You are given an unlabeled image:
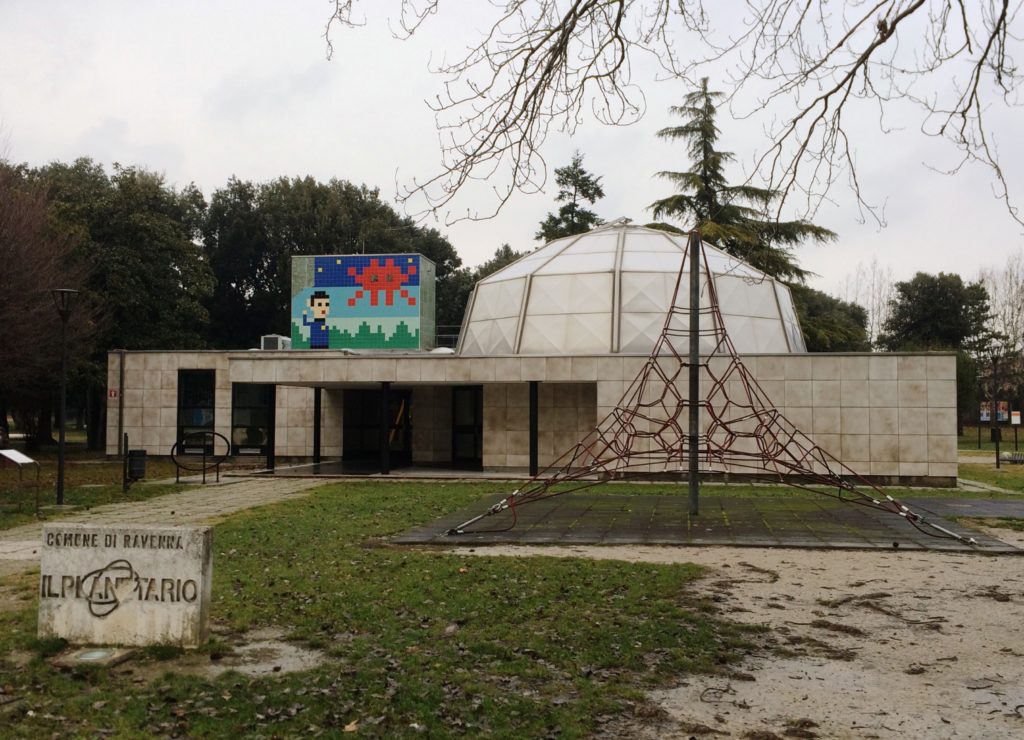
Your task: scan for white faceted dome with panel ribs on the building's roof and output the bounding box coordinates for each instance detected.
[459,221,807,356]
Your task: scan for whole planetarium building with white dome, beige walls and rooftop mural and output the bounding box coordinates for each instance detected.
[108,222,956,484]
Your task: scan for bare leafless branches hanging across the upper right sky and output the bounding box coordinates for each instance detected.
[325,0,1024,226]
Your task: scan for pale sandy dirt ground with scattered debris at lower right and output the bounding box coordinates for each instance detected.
[468,529,1024,740]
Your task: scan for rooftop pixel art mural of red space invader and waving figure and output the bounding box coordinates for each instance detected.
[292,254,434,349]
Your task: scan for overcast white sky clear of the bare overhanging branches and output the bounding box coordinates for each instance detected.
[0,0,1024,293]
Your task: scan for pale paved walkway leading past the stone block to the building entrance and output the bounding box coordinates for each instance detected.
[0,478,325,575]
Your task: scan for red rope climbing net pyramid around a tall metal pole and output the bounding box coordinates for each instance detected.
[449,238,975,545]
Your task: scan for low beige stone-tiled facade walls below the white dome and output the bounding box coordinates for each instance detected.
[106,351,957,485]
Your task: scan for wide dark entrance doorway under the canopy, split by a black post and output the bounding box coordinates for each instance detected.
[341,388,413,470]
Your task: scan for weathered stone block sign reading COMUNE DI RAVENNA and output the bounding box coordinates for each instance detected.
[39,524,213,647]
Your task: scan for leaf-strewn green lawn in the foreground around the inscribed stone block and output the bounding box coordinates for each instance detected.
[0,482,754,737]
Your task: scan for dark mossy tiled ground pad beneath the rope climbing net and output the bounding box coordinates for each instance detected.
[393,492,1024,554]
